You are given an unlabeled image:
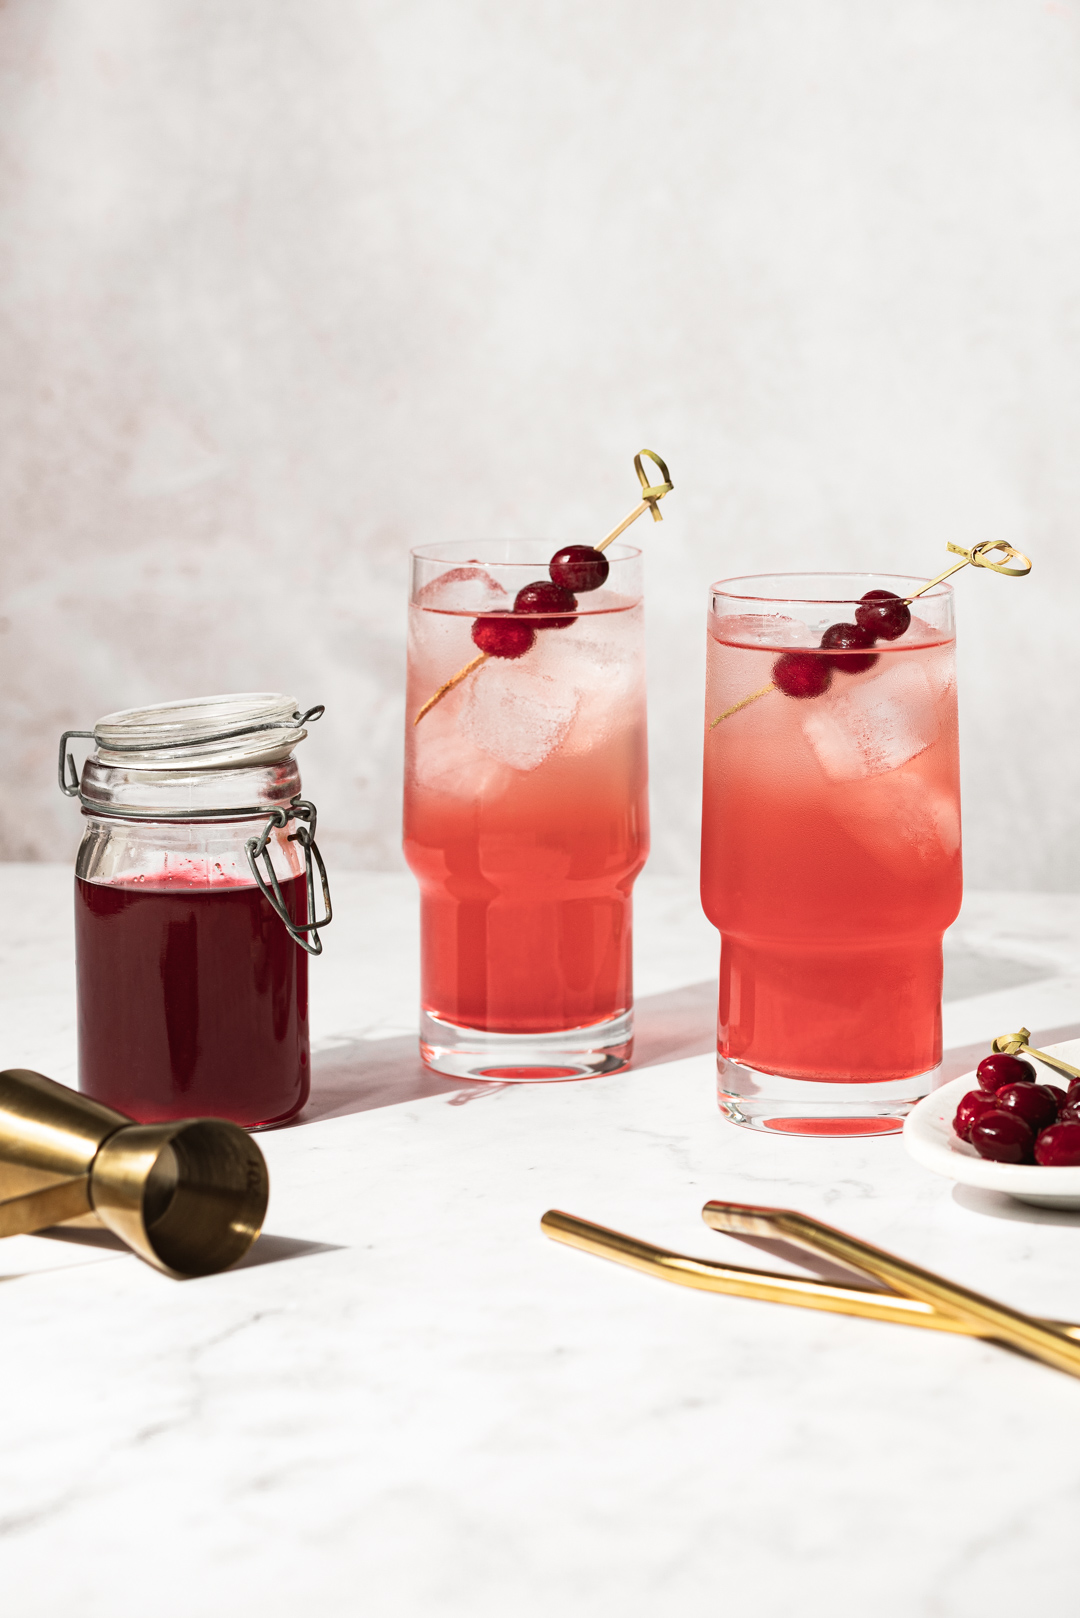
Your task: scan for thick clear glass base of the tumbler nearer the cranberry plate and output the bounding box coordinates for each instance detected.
[716,1055,941,1134]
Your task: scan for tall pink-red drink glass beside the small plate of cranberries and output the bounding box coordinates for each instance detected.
[701,573,960,1134]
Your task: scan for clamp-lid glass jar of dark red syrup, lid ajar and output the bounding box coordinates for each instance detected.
[58,691,332,1129]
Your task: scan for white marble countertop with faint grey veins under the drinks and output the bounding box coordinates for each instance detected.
[0,866,1080,1618]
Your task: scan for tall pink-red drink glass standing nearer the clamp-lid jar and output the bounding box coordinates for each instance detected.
[405,540,649,1082]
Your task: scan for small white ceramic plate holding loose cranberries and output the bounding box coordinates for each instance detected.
[904,1039,1080,1209]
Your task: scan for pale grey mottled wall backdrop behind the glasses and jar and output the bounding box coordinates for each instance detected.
[0,0,1080,888]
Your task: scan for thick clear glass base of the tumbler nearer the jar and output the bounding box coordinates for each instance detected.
[419,1011,633,1084]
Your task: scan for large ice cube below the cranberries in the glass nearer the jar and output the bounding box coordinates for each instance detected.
[460,650,578,770]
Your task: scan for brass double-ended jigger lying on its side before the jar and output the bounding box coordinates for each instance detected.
[0,1068,270,1278]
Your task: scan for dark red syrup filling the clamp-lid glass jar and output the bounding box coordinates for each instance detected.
[74,874,311,1128]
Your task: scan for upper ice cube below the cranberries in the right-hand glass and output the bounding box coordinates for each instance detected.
[803,654,941,781]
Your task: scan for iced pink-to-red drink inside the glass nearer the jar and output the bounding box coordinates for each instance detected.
[405,608,649,1035]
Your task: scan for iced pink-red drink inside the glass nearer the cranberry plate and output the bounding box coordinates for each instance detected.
[701,620,962,1080]
